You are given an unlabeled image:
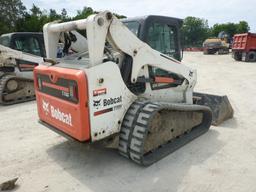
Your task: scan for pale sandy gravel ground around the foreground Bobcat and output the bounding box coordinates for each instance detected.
[0,53,256,192]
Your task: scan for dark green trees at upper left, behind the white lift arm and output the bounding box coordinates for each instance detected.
[0,3,125,35]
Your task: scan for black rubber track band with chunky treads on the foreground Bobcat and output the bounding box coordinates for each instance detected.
[119,101,212,166]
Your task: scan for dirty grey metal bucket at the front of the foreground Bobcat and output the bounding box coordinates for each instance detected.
[193,92,234,126]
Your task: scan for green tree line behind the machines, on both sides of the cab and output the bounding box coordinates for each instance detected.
[0,0,250,47]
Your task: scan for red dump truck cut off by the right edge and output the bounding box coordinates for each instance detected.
[232,33,256,62]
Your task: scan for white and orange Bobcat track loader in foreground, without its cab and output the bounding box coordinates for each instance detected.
[34,11,233,166]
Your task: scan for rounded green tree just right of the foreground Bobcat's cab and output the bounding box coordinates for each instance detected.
[182,16,209,47]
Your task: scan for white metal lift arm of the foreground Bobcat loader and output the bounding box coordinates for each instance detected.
[44,11,196,94]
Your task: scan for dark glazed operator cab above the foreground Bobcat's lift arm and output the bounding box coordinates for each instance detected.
[122,15,183,61]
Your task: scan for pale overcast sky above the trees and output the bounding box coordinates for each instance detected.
[22,0,256,32]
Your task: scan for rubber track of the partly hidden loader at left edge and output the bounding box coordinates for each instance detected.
[0,74,35,105]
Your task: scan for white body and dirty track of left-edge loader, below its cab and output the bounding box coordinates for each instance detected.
[0,45,43,105]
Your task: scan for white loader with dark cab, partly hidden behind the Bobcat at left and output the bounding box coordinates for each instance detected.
[0,31,87,105]
